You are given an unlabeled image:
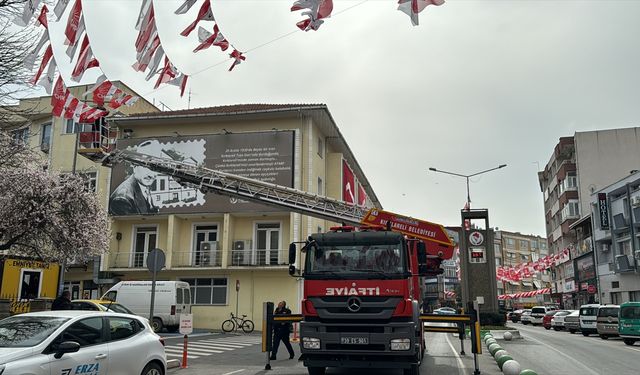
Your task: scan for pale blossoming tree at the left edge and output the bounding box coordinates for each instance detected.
[0,130,109,263]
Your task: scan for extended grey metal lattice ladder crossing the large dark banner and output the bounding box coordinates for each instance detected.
[102,150,367,224]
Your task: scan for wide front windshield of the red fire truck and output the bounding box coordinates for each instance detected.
[305,244,407,279]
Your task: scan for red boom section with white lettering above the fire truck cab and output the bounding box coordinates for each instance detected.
[360,208,453,247]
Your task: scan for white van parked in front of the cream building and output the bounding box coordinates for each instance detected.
[102,281,191,332]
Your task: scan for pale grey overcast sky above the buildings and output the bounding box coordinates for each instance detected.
[42,0,640,236]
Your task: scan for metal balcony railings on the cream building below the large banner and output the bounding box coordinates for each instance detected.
[109,249,288,269]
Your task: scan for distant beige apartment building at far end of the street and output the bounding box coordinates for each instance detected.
[494,230,551,308]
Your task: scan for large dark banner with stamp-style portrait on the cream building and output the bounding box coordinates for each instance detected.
[109,131,294,216]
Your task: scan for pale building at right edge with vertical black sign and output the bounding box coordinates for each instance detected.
[590,173,640,304]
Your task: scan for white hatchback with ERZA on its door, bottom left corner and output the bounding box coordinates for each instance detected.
[0,310,167,375]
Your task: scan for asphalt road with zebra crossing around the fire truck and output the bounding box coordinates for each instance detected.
[165,333,501,375]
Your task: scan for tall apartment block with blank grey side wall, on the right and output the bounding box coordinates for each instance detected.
[538,128,640,301]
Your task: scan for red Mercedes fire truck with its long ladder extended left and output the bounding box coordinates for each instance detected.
[84,132,453,375]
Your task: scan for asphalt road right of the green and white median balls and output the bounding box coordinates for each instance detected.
[498,324,640,375]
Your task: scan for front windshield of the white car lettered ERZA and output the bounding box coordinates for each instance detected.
[0,315,69,348]
